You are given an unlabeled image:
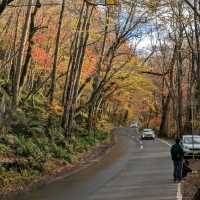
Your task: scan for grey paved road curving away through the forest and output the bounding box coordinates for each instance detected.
[15,128,177,200]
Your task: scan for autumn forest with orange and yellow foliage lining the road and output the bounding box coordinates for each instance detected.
[0,0,200,192]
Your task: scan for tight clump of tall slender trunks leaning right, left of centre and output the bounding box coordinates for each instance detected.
[62,3,94,137]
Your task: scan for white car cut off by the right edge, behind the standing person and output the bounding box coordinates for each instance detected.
[181,135,200,157]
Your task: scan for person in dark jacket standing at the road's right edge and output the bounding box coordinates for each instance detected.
[171,138,184,182]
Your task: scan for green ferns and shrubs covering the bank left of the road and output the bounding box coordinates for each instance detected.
[0,101,111,193]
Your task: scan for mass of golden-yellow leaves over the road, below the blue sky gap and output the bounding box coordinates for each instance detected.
[109,62,158,121]
